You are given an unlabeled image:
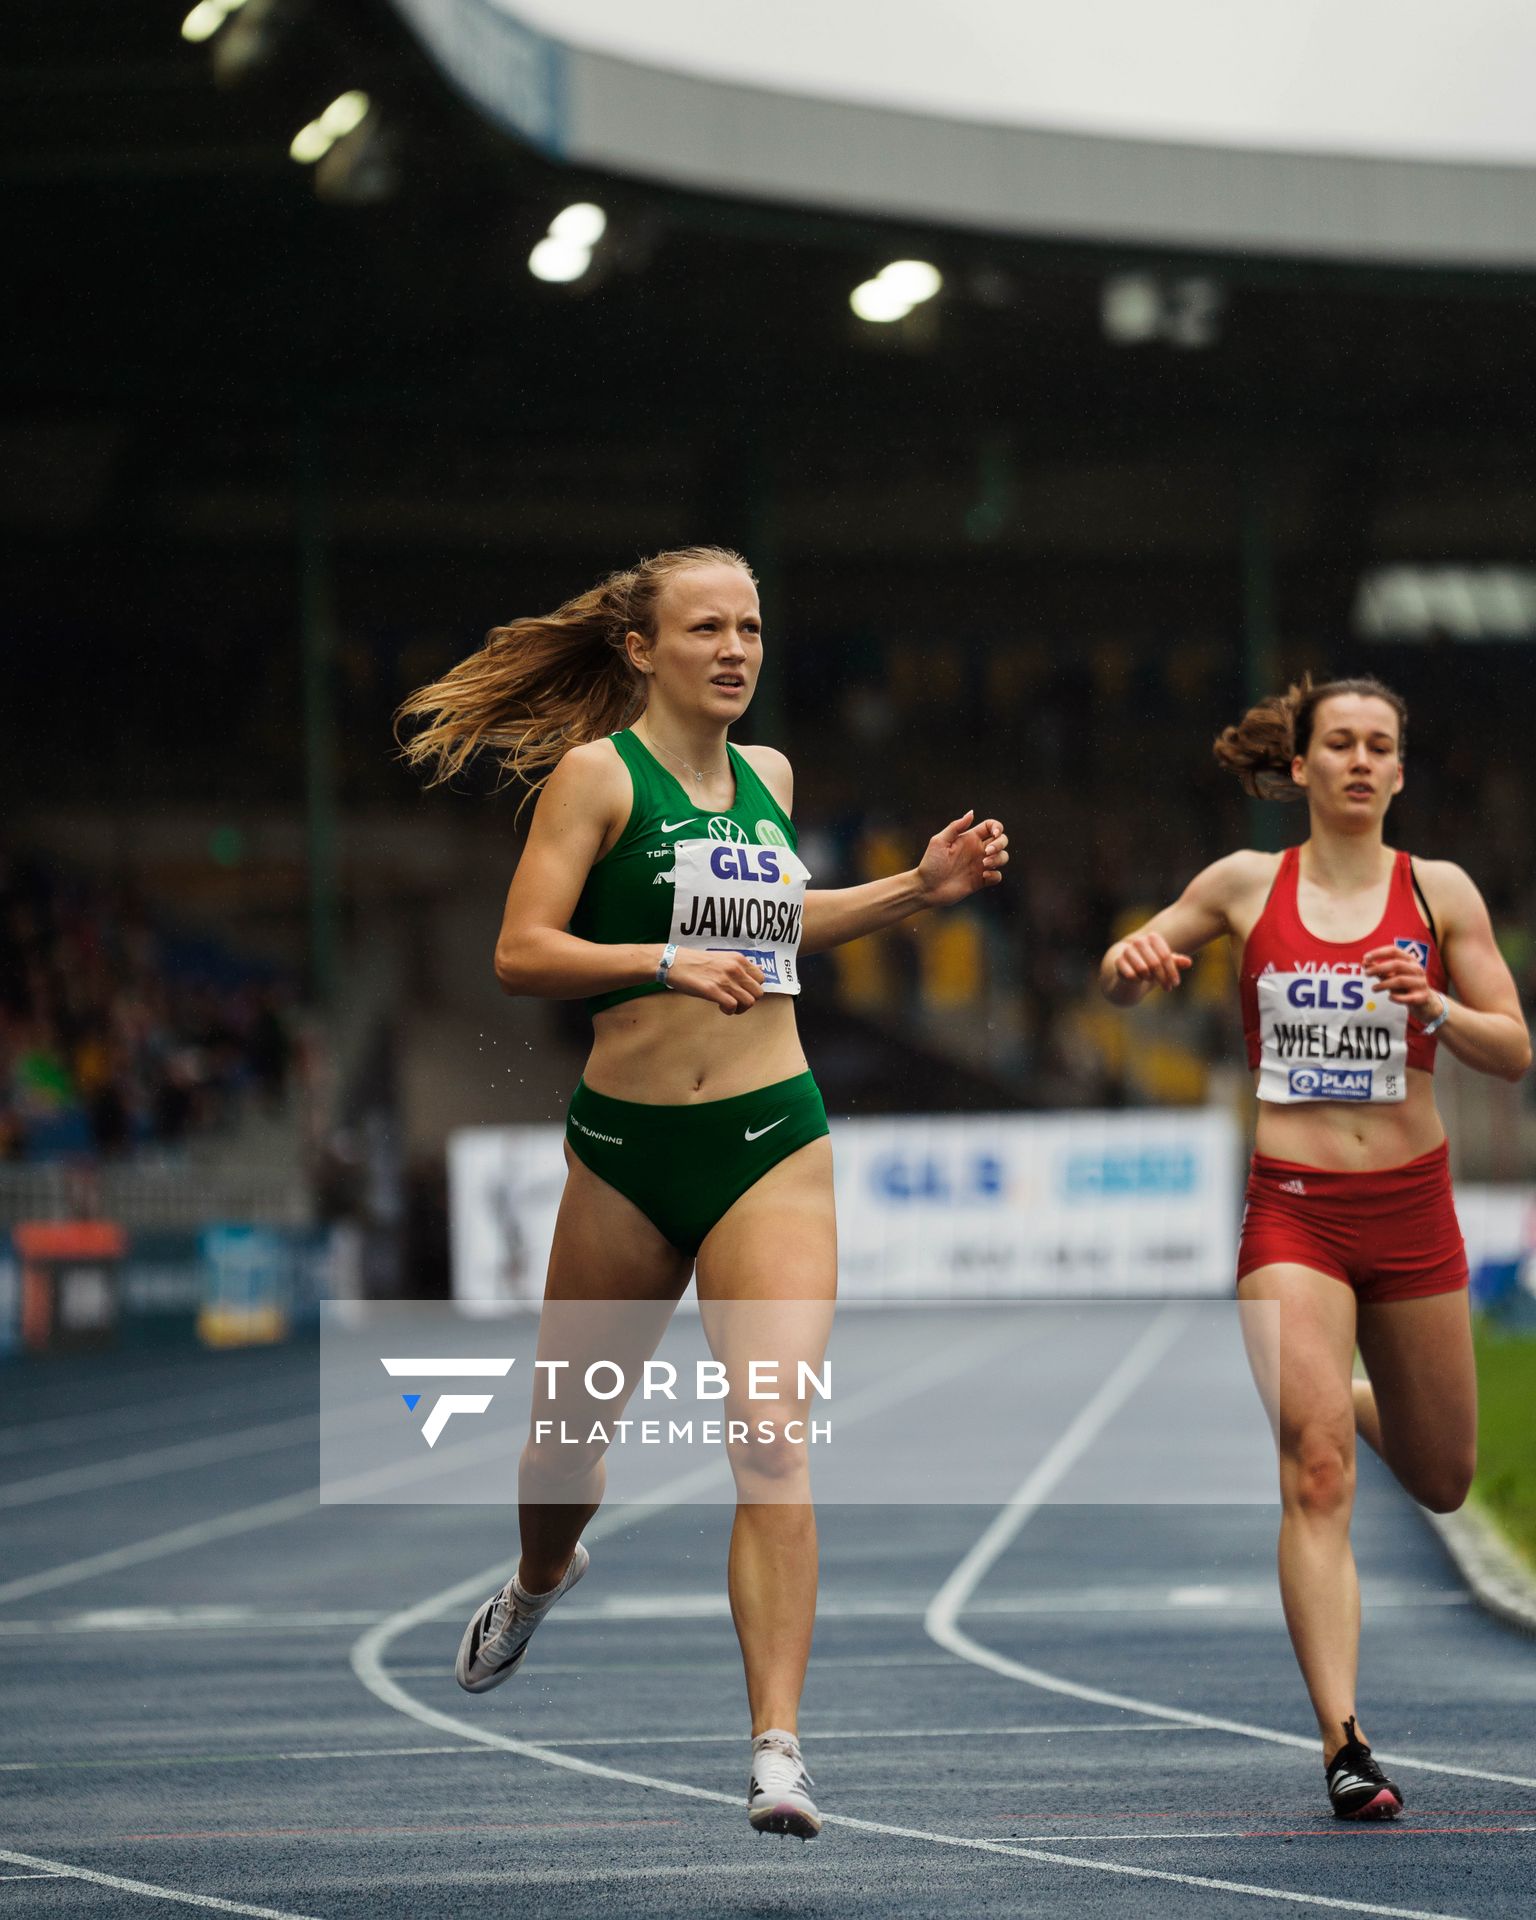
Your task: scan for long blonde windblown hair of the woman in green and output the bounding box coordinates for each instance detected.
[396,547,755,791]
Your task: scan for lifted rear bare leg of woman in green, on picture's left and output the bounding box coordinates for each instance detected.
[516,1148,691,1594]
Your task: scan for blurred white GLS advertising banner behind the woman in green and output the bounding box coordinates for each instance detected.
[449,1110,1240,1300]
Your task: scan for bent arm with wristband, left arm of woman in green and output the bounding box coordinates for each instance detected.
[495,741,762,1014]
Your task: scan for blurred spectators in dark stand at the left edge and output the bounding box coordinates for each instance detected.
[0,849,296,1162]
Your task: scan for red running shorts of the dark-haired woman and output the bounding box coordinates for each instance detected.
[1236,1140,1467,1302]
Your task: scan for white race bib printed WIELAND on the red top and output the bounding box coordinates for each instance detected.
[1256,973,1407,1106]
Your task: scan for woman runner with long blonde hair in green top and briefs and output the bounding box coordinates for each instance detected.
[401,547,1008,1839]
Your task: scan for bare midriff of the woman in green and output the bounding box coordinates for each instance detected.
[584,993,806,1106]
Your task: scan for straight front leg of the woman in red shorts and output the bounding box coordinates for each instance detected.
[1238,1265,1365,1763]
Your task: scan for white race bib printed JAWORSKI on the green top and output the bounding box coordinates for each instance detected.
[668,839,810,993]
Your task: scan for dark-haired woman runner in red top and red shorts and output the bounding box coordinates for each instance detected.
[1100,680,1530,1820]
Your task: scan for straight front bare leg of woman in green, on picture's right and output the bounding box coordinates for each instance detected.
[699,1139,837,1734]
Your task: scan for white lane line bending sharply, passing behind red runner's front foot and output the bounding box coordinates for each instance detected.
[924,1317,1536,1789]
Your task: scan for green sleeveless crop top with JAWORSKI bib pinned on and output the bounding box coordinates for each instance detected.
[570,728,808,1014]
